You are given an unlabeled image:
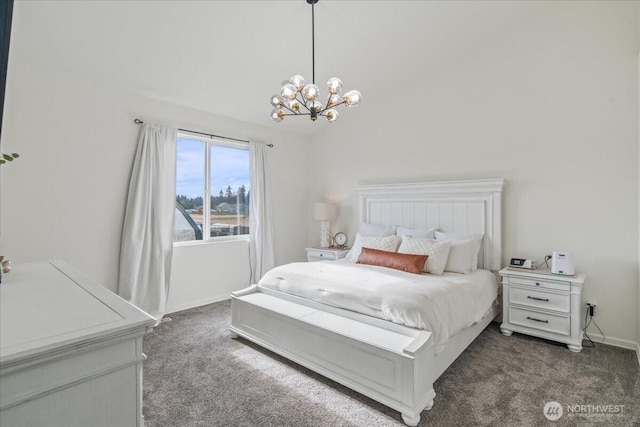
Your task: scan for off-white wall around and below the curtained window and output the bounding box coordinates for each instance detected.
[0,2,308,311]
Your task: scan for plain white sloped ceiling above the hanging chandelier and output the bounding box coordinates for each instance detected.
[14,0,544,135]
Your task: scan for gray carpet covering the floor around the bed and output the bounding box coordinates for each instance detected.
[144,301,640,427]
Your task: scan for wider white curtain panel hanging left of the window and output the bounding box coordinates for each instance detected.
[118,123,177,322]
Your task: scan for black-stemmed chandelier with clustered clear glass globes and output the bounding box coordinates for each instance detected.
[271,0,362,123]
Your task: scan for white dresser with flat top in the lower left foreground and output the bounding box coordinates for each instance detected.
[0,261,155,427]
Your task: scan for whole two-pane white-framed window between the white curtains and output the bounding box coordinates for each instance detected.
[173,134,250,242]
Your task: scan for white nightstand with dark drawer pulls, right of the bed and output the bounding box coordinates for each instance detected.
[499,268,585,352]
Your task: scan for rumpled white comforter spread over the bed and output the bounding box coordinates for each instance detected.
[258,261,499,353]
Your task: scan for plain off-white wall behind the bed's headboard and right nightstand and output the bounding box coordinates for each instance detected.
[308,2,639,348]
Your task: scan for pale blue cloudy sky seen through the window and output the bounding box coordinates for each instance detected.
[176,137,249,197]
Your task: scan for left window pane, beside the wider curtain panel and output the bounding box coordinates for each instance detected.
[173,137,205,242]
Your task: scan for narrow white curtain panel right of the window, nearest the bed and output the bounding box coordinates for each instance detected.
[249,142,275,283]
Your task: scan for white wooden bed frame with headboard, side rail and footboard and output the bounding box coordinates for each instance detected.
[230,179,504,426]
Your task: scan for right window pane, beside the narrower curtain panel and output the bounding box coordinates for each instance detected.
[210,145,250,237]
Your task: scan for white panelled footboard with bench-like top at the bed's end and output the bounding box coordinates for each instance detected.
[230,285,435,425]
